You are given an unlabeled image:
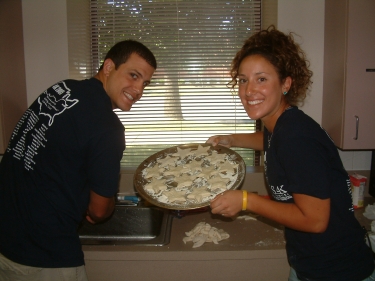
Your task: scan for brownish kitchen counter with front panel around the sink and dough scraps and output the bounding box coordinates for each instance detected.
[83,198,374,281]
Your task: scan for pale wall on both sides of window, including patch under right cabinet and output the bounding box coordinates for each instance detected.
[22,0,371,170]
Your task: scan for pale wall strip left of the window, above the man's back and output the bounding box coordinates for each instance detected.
[22,0,69,105]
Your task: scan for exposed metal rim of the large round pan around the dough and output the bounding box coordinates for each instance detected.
[133,143,246,210]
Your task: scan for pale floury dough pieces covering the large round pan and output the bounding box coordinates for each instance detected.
[142,145,238,206]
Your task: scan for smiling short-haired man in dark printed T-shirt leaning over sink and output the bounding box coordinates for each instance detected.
[0,40,157,280]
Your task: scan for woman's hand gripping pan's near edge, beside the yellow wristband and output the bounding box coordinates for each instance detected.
[210,190,243,217]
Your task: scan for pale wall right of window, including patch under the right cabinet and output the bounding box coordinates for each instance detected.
[277,0,372,170]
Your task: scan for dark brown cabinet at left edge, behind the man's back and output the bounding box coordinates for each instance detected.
[0,0,27,154]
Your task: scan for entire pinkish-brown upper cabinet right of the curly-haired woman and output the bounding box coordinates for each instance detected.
[322,0,375,150]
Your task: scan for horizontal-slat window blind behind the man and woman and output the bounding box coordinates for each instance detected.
[84,0,261,167]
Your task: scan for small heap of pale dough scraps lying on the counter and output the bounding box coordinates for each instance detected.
[182,222,229,248]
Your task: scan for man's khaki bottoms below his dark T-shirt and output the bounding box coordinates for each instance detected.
[0,253,87,281]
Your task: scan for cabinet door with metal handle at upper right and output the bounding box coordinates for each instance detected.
[342,0,375,149]
